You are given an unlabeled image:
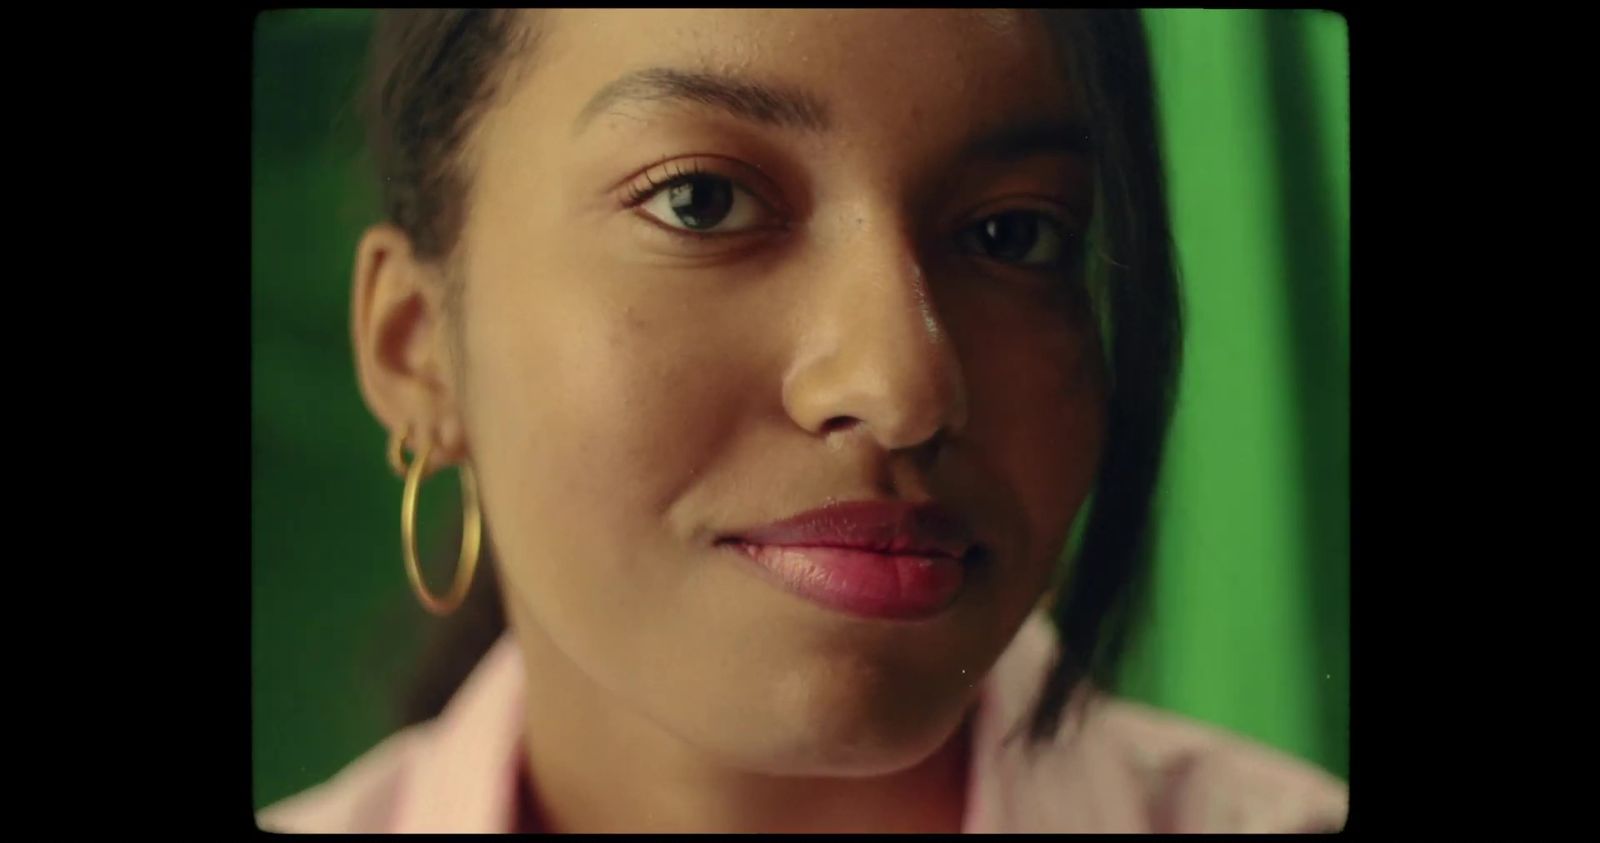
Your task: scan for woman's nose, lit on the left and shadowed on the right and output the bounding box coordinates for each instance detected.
[784,219,966,451]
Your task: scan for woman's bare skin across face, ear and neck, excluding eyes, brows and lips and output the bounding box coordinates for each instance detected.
[354,10,1104,832]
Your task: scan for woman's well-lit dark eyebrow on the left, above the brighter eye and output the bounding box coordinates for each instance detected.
[573,67,829,134]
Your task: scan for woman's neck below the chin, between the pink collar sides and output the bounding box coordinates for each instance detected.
[514,614,971,833]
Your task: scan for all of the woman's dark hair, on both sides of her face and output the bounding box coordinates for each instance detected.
[368,10,1182,742]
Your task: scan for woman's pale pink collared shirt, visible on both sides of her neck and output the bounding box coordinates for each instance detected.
[258,614,1349,833]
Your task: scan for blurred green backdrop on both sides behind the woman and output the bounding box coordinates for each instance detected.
[251,10,1349,808]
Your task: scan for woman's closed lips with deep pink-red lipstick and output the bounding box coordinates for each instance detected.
[718,501,976,619]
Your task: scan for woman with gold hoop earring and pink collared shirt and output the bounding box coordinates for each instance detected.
[261,10,1346,832]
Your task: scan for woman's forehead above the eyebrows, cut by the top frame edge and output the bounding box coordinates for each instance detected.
[507,10,1072,141]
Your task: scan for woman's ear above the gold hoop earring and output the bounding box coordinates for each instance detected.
[350,224,466,465]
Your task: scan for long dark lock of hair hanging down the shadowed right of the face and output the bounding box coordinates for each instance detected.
[1029,10,1182,741]
